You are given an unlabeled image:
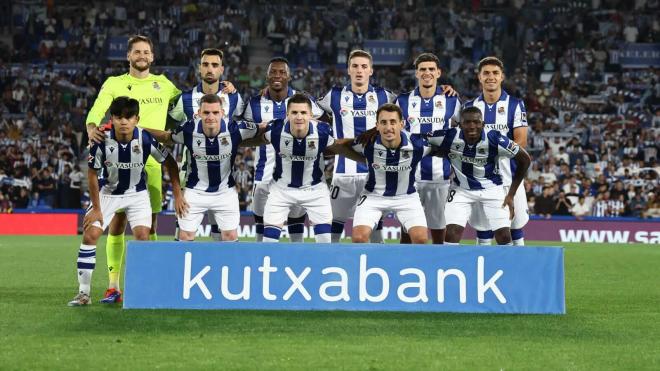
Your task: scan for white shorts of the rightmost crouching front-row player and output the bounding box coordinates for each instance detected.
[445,185,511,231]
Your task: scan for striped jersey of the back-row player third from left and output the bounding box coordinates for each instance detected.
[243,87,323,183]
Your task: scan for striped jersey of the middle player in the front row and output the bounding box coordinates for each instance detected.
[265,120,335,188]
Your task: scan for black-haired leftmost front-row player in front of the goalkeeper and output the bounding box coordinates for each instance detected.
[69,97,187,306]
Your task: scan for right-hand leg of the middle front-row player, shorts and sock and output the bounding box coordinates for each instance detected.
[300,183,332,243]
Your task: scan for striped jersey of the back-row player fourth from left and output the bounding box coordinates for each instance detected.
[318,85,395,175]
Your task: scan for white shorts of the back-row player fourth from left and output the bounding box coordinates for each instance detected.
[330,174,367,222]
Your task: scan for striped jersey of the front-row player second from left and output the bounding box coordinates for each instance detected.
[172,119,258,192]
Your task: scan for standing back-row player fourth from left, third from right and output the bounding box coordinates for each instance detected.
[319,50,395,243]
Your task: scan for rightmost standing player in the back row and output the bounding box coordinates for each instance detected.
[465,57,529,245]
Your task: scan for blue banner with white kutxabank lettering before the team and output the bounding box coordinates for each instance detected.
[124,241,566,314]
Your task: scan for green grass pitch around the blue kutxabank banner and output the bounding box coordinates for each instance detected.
[0,236,660,370]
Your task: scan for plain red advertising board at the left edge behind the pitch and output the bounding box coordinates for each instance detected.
[0,214,78,236]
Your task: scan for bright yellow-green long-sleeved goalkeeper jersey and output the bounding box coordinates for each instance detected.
[85,74,181,130]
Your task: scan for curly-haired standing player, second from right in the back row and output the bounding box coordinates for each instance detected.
[396,53,461,244]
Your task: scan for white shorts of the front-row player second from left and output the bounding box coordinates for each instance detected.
[179,187,241,232]
